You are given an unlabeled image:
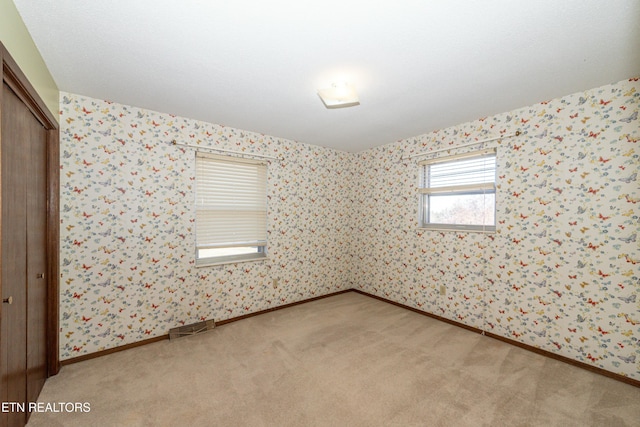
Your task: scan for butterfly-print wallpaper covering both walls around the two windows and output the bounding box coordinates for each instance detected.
[60,79,640,379]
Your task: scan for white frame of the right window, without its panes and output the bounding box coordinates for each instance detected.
[418,148,497,233]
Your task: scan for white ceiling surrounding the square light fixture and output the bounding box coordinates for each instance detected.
[14,0,640,152]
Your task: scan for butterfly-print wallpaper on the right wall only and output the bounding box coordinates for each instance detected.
[351,79,640,380]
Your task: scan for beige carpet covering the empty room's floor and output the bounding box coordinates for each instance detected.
[28,292,640,427]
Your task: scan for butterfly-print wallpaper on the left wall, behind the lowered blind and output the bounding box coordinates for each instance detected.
[60,93,351,360]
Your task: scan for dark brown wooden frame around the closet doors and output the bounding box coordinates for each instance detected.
[0,42,60,377]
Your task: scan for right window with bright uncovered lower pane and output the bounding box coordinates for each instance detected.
[420,149,496,231]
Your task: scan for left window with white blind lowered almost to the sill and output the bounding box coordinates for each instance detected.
[196,153,267,266]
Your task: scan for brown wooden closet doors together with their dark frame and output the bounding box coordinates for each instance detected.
[0,44,59,427]
